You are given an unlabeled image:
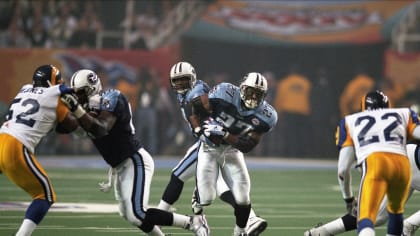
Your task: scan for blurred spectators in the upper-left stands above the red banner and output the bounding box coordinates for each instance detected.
[0,0,179,48]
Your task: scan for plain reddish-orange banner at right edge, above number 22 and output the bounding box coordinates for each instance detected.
[384,50,420,92]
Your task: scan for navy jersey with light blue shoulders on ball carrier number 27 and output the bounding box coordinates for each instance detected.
[209,83,277,135]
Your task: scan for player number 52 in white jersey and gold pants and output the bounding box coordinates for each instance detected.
[0,65,78,236]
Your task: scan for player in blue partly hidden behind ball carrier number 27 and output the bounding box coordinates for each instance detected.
[158,62,267,236]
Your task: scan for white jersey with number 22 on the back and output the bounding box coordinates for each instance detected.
[337,108,419,164]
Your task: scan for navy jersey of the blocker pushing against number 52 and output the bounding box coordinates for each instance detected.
[92,89,141,167]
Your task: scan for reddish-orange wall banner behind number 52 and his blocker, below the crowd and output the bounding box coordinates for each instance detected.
[0,45,179,104]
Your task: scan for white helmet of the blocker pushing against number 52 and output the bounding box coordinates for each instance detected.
[70,69,102,98]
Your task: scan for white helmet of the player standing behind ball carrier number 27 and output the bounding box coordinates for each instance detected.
[169,62,197,94]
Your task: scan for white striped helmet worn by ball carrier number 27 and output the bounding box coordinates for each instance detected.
[239,72,268,109]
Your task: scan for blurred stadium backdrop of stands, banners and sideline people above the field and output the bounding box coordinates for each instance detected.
[0,0,420,159]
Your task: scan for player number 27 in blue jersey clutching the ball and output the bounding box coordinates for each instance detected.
[196,72,277,236]
